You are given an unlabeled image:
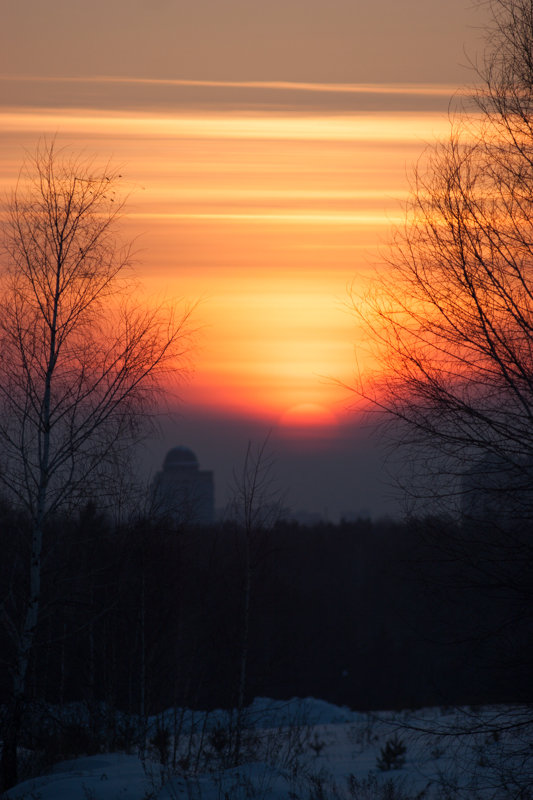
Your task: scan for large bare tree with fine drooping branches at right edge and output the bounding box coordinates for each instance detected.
[354,0,533,796]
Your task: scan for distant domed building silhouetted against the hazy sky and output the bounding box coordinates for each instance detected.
[152,445,215,525]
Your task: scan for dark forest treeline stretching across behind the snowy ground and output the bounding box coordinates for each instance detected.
[0,505,531,715]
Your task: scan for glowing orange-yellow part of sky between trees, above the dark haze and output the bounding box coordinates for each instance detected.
[0,89,454,424]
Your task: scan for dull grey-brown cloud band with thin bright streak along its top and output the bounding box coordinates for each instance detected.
[0,75,456,112]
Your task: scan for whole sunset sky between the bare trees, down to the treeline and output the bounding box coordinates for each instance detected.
[0,0,483,519]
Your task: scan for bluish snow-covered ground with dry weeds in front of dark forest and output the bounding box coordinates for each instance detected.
[7,699,533,800]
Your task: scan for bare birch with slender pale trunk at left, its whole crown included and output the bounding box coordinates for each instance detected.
[0,143,190,788]
